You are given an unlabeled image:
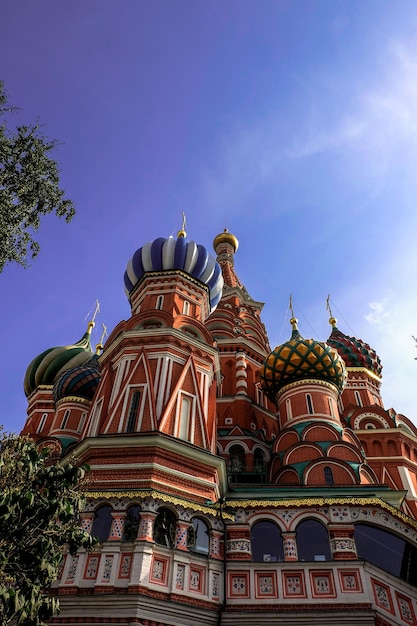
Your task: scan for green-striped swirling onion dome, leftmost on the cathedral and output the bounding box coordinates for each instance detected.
[24,322,94,396]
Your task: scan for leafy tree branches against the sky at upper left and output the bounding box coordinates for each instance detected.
[0,81,75,272]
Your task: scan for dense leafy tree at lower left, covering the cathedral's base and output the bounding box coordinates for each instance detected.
[0,428,94,626]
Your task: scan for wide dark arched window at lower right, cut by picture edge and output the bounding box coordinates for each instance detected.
[354,524,417,585]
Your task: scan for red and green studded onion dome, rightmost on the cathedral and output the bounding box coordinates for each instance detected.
[327,317,382,378]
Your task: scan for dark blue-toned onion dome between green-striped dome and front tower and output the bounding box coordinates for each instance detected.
[53,353,100,402]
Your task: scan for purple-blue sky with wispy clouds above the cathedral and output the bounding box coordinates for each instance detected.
[0,0,417,431]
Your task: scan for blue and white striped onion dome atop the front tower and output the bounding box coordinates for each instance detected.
[124,236,223,311]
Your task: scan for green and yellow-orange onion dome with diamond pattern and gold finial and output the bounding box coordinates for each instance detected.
[261,318,347,400]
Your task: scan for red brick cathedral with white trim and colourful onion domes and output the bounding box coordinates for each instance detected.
[23,230,417,626]
